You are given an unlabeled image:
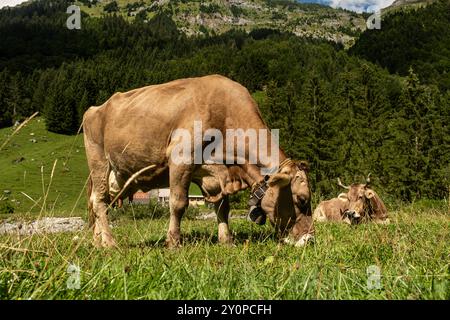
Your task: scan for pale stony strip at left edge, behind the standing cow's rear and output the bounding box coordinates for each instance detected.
[0,217,86,235]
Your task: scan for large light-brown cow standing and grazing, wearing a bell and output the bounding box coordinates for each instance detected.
[83,75,314,247]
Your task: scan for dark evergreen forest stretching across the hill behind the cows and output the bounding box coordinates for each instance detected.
[0,2,450,201]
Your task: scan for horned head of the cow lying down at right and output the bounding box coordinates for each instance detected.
[338,173,376,223]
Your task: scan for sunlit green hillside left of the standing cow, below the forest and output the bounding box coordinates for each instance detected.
[0,118,89,213]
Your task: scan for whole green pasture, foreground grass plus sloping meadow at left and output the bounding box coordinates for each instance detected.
[0,119,450,300]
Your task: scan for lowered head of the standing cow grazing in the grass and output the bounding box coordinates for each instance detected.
[261,161,314,246]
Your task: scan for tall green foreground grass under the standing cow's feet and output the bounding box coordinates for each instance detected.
[0,206,450,299]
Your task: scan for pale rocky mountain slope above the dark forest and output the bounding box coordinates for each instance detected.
[77,0,365,44]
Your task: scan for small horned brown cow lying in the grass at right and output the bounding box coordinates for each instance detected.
[313,174,389,224]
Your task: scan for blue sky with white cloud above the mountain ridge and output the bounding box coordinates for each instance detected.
[0,0,394,12]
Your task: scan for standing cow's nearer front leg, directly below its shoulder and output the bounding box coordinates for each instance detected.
[166,164,193,248]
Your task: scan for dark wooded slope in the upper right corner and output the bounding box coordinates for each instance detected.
[350,0,450,90]
